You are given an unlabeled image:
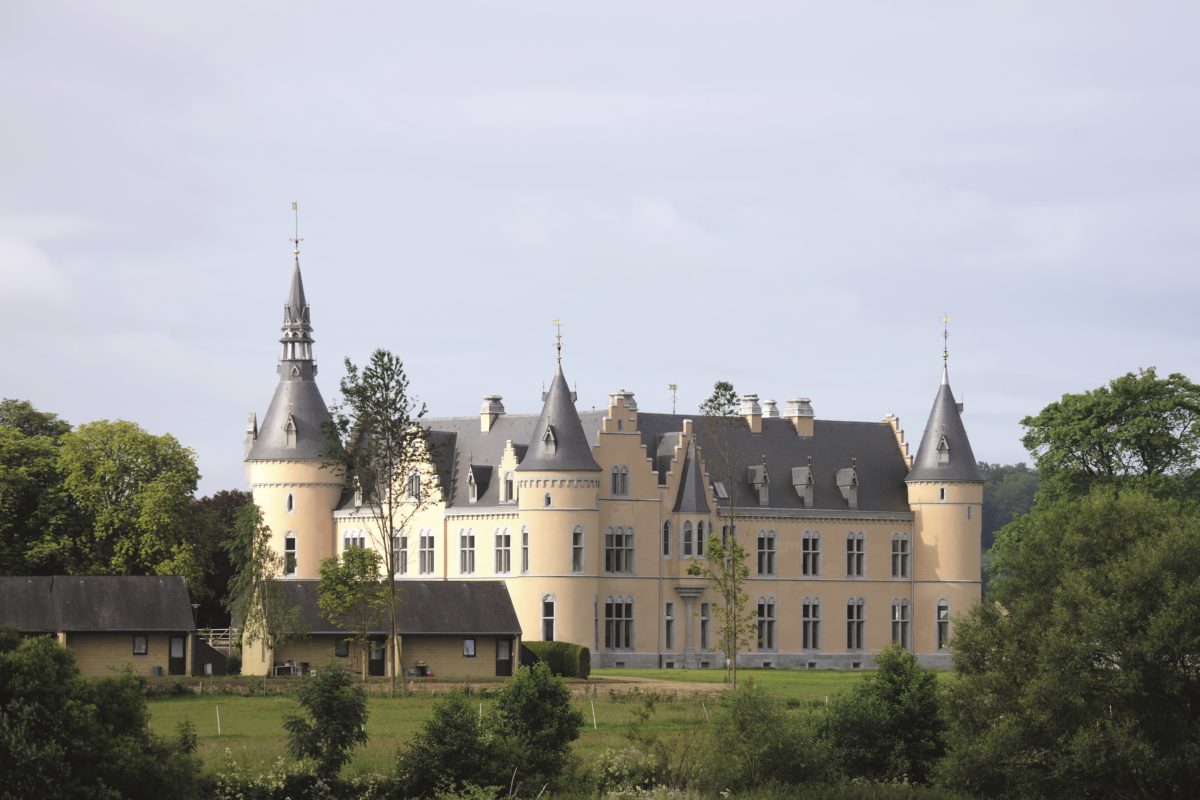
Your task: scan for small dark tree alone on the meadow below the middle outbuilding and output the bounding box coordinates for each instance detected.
[283,664,367,778]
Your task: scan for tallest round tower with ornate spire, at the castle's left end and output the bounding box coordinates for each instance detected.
[246,251,342,578]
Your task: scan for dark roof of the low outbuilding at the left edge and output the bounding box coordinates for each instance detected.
[0,576,196,632]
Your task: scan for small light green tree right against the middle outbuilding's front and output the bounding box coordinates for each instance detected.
[317,547,386,680]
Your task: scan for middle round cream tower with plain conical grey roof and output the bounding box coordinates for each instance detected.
[508,361,601,648]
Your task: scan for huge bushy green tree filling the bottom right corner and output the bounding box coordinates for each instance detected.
[942,489,1200,798]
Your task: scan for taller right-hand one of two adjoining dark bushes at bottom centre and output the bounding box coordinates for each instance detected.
[493,663,583,788]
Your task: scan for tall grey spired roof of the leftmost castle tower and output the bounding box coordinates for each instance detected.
[246,258,330,461]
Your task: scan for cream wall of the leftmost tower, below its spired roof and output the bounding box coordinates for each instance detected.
[246,461,342,578]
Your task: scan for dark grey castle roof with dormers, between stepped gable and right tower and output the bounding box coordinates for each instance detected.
[637,413,908,511]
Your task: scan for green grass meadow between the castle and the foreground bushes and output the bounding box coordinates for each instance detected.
[150,669,865,775]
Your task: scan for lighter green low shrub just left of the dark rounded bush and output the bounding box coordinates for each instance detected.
[703,681,832,792]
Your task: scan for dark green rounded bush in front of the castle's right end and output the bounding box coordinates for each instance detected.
[821,644,946,783]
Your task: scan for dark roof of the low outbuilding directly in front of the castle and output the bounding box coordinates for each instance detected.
[280,581,521,636]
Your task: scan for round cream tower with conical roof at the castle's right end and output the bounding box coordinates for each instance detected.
[893,365,984,661]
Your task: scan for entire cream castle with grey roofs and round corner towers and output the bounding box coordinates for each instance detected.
[245,259,984,668]
